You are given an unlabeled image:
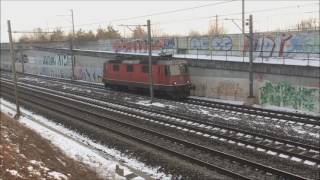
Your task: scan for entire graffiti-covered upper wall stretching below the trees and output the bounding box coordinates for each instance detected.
[70,31,320,57]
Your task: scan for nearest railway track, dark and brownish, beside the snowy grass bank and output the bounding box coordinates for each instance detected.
[1,80,316,179]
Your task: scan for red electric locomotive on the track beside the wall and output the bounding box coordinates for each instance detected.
[102,58,191,99]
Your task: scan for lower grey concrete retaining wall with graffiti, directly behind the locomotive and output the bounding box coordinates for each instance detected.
[1,50,320,112]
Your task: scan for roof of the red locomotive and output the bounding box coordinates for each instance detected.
[108,58,187,65]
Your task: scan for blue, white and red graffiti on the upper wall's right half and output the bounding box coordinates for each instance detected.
[184,31,320,57]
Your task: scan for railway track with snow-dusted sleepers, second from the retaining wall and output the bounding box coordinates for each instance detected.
[1,74,320,164]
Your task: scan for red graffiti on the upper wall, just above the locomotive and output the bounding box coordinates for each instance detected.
[112,38,175,52]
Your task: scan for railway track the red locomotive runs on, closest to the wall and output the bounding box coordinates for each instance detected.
[2,70,320,126]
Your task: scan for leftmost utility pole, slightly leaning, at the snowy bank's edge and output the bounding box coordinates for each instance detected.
[7,20,20,119]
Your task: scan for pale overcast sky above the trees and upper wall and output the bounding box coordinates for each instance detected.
[1,0,319,42]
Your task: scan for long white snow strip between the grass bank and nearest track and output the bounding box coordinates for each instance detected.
[0,98,171,179]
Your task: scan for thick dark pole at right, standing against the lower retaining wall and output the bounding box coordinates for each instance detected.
[249,15,253,98]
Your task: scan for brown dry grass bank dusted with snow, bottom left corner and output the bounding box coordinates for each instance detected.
[0,113,105,180]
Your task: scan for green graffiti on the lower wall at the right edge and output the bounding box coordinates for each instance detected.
[260,82,319,111]
